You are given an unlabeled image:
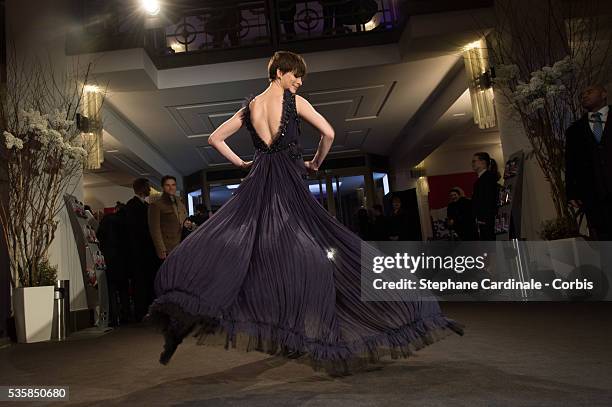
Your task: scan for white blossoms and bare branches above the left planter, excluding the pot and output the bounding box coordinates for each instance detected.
[0,109,87,286]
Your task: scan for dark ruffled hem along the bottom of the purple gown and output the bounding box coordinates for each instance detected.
[147,291,464,375]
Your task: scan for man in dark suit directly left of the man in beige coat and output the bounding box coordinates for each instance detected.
[126,178,160,321]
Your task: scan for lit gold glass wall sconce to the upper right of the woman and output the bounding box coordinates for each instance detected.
[463,39,496,129]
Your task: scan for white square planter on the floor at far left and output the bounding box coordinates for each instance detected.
[13,285,55,343]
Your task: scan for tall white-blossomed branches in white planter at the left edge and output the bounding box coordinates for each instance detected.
[0,49,101,342]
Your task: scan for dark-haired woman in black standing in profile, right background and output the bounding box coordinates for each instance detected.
[472,152,501,241]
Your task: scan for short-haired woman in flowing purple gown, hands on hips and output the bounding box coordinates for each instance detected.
[149,52,463,371]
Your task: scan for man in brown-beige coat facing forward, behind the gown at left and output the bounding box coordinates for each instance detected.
[149,175,187,260]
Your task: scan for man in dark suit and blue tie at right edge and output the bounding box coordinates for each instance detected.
[565,85,612,240]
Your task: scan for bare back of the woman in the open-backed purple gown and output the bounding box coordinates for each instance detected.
[249,91,283,146]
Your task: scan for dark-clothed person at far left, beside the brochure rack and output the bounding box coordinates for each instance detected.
[97,202,130,326]
